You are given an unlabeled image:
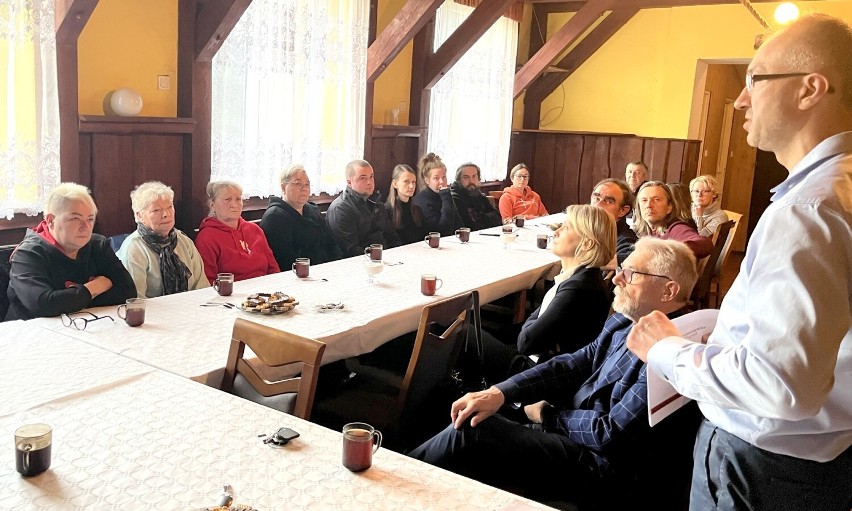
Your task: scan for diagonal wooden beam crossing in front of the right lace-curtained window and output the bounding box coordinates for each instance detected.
[424,0,515,89]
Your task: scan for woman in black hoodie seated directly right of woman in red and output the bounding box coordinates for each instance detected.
[260,164,343,270]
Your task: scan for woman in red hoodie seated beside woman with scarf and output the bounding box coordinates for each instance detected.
[195,181,281,283]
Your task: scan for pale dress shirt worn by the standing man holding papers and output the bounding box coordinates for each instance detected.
[648,132,852,462]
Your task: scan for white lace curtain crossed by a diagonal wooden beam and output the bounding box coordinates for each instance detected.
[428,2,518,181]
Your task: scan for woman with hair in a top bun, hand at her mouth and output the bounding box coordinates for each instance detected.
[414,153,462,236]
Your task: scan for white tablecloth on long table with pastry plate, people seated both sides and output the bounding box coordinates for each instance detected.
[26,215,562,379]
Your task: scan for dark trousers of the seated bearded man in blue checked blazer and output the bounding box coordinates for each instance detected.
[408,415,599,500]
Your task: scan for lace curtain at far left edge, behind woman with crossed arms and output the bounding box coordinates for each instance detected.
[0,0,59,219]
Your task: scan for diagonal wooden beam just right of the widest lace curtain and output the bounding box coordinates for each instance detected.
[367,0,444,83]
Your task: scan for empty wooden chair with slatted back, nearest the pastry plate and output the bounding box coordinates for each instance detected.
[219,318,325,420]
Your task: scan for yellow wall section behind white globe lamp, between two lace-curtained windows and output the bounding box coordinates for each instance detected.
[77,0,178,117]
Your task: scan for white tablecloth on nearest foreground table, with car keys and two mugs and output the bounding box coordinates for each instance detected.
[0,336,546,511]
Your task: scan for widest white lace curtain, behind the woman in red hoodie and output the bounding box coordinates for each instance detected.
[211,0,369,197]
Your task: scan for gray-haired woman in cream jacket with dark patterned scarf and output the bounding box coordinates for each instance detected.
[116,181,210,298]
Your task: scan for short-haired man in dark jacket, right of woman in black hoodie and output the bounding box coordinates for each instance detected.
[325,160,399,257]
